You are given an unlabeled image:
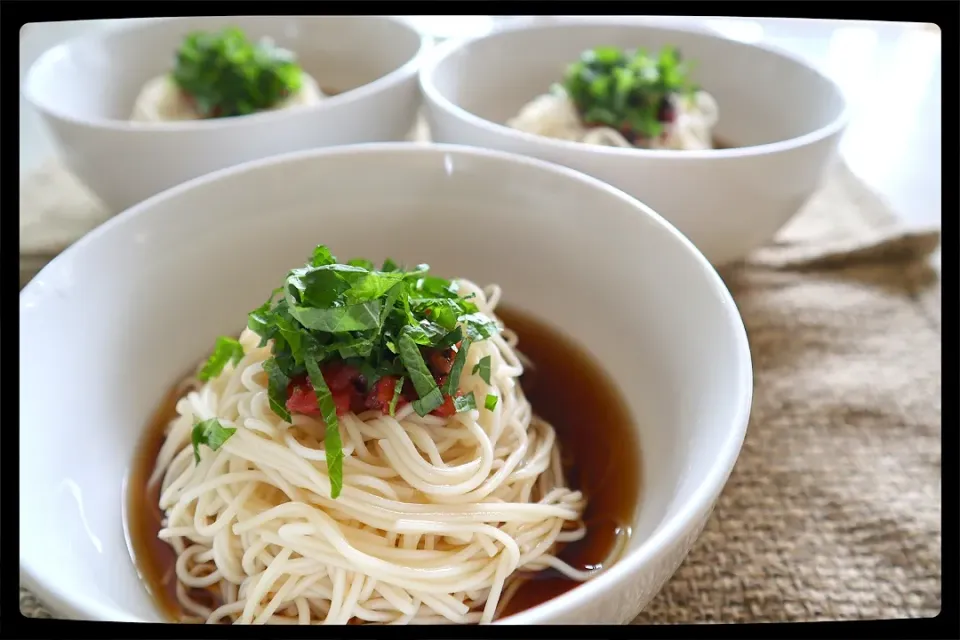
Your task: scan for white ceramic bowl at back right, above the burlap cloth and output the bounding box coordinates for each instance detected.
[420,19,846,264]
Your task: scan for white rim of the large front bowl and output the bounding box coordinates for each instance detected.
[20,142,753,625]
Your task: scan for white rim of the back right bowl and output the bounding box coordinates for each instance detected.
[419,16,850,162]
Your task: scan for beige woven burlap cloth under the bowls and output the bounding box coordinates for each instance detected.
[20,119,941,624]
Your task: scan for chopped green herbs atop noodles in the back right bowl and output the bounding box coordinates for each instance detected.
[562,47,697,140]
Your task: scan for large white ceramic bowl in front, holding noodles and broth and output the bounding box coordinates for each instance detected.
[20,143,752,624]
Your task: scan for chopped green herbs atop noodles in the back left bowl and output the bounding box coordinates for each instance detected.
[172,27,303,118]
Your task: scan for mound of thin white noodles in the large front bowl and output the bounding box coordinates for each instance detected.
[152,280,626,624]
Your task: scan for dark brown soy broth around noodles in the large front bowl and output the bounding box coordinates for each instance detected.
[126,307,641,622]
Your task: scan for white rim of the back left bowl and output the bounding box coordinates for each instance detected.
[21,15,433,132]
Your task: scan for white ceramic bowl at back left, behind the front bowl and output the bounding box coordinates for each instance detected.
[23,16,428,211]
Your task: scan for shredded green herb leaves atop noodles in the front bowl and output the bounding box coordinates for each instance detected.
[202,245,500,498]
